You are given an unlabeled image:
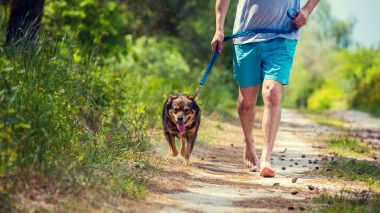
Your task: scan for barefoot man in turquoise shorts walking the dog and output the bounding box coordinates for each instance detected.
[211,0,319,177]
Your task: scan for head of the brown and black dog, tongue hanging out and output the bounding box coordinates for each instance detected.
[167,95,199,133]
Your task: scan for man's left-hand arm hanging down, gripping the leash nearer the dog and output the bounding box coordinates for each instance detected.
[211,0,230,53]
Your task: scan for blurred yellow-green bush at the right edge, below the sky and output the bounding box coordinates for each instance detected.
[308,48,380,110]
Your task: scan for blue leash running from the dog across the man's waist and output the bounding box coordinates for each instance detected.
[194,9,298,97]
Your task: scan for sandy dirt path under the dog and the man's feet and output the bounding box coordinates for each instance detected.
[131,109,376,212]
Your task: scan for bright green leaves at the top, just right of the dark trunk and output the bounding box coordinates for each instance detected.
[43,0,131,53]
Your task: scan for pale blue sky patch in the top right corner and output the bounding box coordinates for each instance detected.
[321,0,380,47]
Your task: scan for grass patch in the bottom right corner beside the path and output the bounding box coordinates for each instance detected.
[314,190,380,213]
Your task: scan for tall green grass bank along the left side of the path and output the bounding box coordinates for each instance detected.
[0,34,150,210]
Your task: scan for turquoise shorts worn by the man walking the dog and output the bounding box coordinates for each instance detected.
[233,38,297,87]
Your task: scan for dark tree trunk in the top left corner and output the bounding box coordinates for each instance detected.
[6,0,45,43]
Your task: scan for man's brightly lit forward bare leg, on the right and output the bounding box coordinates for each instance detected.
[260,79,283,177]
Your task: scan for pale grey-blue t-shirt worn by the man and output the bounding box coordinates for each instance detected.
[233,0,300,44]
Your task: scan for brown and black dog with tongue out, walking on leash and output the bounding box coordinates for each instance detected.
[162,94,201,165]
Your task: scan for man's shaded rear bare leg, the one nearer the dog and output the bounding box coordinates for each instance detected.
[237,85,259,171]
